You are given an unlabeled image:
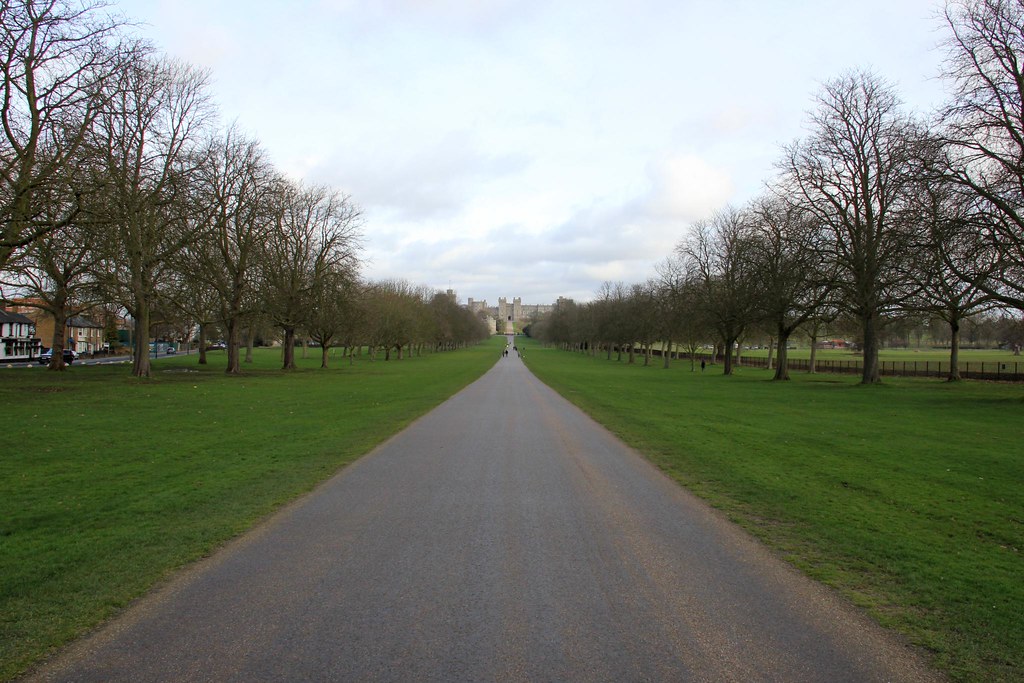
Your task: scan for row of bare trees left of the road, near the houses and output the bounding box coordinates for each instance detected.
[0,0,489,376]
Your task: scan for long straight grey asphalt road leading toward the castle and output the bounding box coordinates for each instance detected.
[25,354,936,683]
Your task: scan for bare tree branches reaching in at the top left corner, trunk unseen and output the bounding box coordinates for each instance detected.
[0,0,129,268]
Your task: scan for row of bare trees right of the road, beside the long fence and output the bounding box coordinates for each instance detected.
[539,0,1024,383]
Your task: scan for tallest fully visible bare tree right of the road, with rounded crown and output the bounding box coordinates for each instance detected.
[780,72,916,384]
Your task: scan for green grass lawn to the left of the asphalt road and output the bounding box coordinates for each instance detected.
[0,337,505,680]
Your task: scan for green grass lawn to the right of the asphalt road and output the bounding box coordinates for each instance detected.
[519,342,1024,681]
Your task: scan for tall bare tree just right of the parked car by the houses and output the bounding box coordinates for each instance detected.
[96,58,211,377]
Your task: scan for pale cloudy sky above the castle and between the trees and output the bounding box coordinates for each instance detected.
[115,0,945,305]
